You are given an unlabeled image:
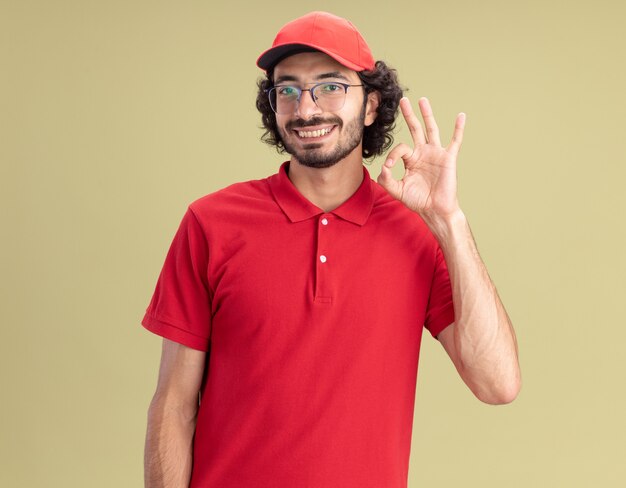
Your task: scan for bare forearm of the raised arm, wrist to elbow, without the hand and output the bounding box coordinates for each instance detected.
[425,210,521,403]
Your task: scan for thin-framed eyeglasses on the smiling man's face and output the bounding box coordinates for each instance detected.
[265,81,364,114]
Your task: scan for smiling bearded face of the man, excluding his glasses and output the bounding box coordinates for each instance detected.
[274,52,375,168]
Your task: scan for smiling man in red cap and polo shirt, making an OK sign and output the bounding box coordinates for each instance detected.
[142,12,520,488]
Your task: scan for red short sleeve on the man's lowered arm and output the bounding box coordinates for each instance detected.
[141,207,211,351]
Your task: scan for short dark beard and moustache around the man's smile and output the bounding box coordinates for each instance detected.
[278,103,366,168]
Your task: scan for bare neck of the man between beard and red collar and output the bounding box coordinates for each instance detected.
[289,153,363,212]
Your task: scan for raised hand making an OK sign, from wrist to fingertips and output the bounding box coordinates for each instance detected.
[378,97,465,218]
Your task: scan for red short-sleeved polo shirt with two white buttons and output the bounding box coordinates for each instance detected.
[142,163,454,488]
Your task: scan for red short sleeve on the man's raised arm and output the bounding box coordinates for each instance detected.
[424,245,454,338]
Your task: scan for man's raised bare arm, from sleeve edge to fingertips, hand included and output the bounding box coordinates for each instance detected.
[378,98,521,404]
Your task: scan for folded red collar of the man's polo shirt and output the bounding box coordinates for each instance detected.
[268,161,374,225]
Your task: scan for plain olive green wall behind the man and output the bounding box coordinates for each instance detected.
[0,0,626,488]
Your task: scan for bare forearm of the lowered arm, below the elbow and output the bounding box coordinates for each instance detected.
[144,396,196,488]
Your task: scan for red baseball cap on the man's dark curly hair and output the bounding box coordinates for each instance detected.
[256,12,376,71]
